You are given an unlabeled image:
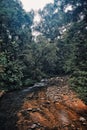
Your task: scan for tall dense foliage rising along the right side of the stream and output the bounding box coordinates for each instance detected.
[36,0,87,101]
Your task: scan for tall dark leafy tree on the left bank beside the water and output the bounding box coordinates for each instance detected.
[0,0,32,89]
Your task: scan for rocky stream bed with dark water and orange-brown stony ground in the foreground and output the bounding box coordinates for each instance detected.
[0,77,87,130]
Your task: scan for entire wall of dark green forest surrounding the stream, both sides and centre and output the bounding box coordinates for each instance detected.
[0,0,87,103]
